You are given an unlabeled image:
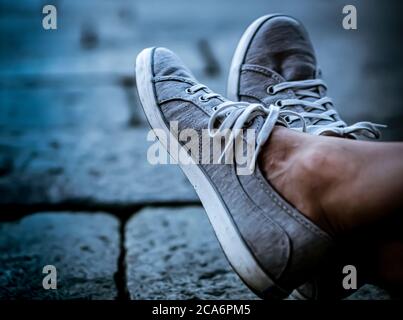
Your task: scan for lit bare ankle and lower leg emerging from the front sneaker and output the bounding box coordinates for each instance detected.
[259,127,402,235]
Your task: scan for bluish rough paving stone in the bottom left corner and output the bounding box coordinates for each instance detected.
[0,212,119,299]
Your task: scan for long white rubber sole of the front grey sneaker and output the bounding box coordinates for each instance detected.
[136,48,275,294]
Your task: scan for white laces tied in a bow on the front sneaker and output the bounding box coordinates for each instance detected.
[186,84,306,172]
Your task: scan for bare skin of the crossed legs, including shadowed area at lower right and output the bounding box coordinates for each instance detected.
[259,127,403,292]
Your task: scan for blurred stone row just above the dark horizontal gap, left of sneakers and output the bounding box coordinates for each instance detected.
[0,129,199,206]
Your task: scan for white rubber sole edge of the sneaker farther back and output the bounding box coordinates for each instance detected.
[227,14,282,101]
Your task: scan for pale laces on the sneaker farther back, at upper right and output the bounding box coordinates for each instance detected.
[267,79,386,139]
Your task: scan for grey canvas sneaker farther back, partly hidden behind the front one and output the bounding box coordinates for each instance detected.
[227,14,383,300]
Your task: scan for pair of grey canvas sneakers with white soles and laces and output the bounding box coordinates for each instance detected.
[136,14,379,299]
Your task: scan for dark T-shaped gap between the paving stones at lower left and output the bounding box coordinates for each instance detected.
[0,201,201,300]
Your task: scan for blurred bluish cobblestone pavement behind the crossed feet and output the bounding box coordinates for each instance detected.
[0,0,403,299]
